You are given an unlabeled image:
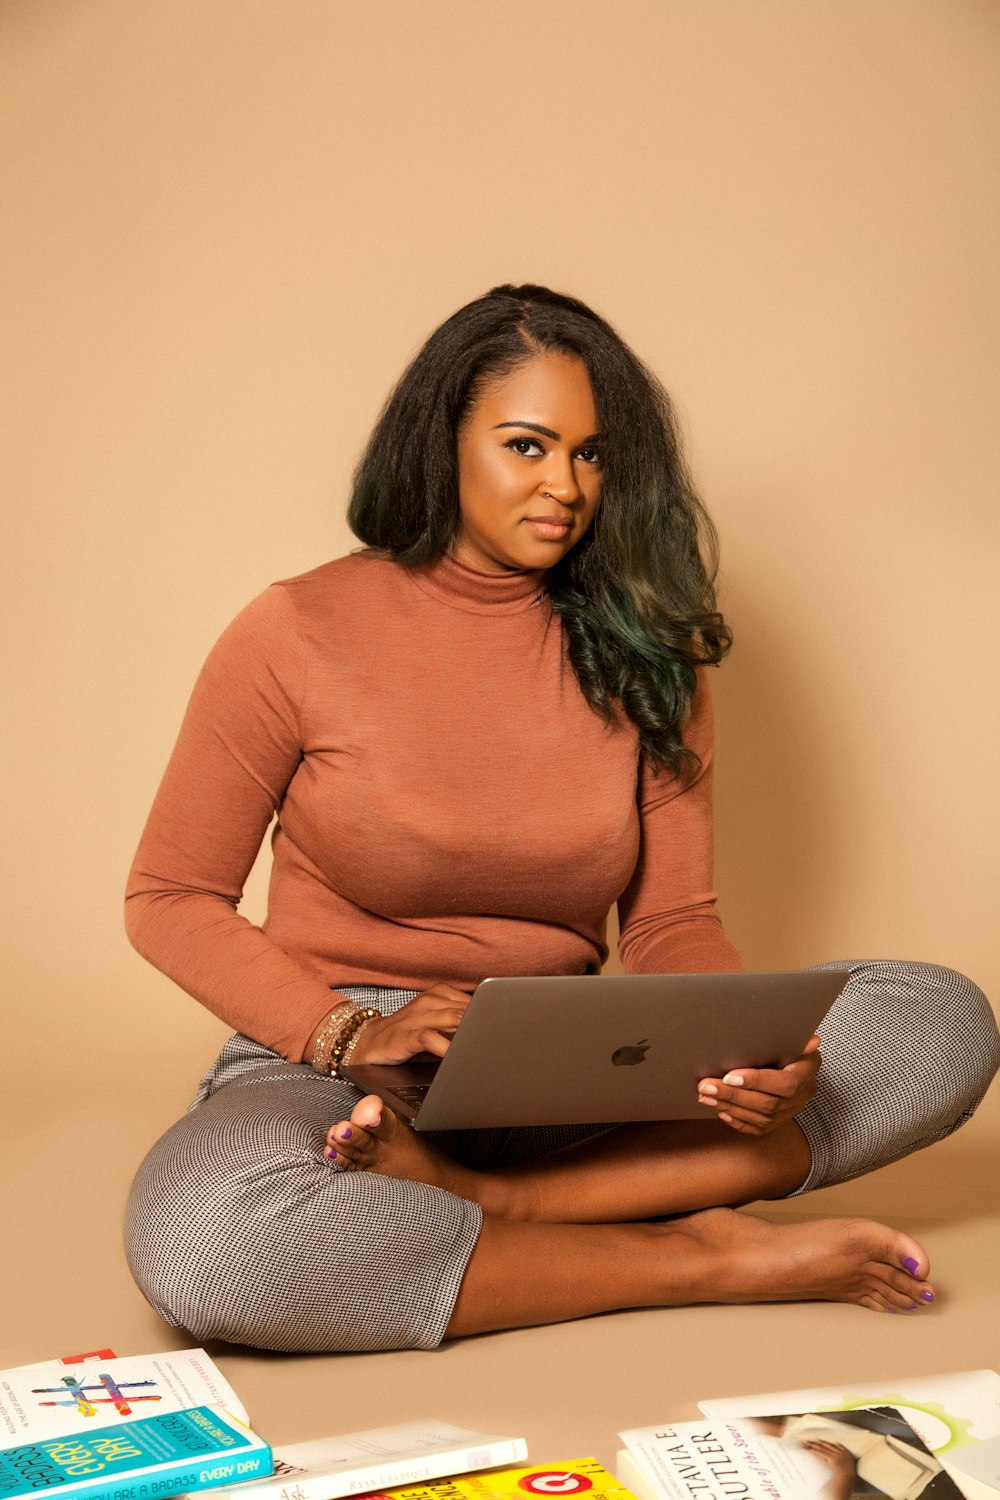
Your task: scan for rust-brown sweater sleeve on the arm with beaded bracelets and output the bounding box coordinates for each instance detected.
[126,587,338,1062]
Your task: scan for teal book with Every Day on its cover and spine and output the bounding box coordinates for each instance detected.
[0,1406,273,1500]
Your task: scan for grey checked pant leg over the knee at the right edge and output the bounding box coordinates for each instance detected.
[790,960,1000,1197]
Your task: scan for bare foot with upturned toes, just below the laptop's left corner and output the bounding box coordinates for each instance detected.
[325,1094,528,1218]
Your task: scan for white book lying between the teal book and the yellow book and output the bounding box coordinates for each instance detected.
[203,1418,528,1500]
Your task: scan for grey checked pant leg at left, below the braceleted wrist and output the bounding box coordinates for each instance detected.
[126,1056,481,1353]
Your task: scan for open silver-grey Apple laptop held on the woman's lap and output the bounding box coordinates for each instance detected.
[343,969,849,1131]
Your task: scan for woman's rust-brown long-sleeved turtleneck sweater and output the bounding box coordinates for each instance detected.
[126,554,741,1061]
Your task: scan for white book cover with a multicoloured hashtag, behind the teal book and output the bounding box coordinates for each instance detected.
[0,1349,249,1449]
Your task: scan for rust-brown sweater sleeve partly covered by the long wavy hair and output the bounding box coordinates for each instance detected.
[618,668,744,974]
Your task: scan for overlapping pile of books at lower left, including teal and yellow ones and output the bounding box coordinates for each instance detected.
[0,1349,630,1500]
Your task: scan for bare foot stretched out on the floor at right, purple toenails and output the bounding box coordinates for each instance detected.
[661,1209,934,1313]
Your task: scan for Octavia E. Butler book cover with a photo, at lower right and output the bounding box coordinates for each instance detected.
[619,1407,963,1500]
